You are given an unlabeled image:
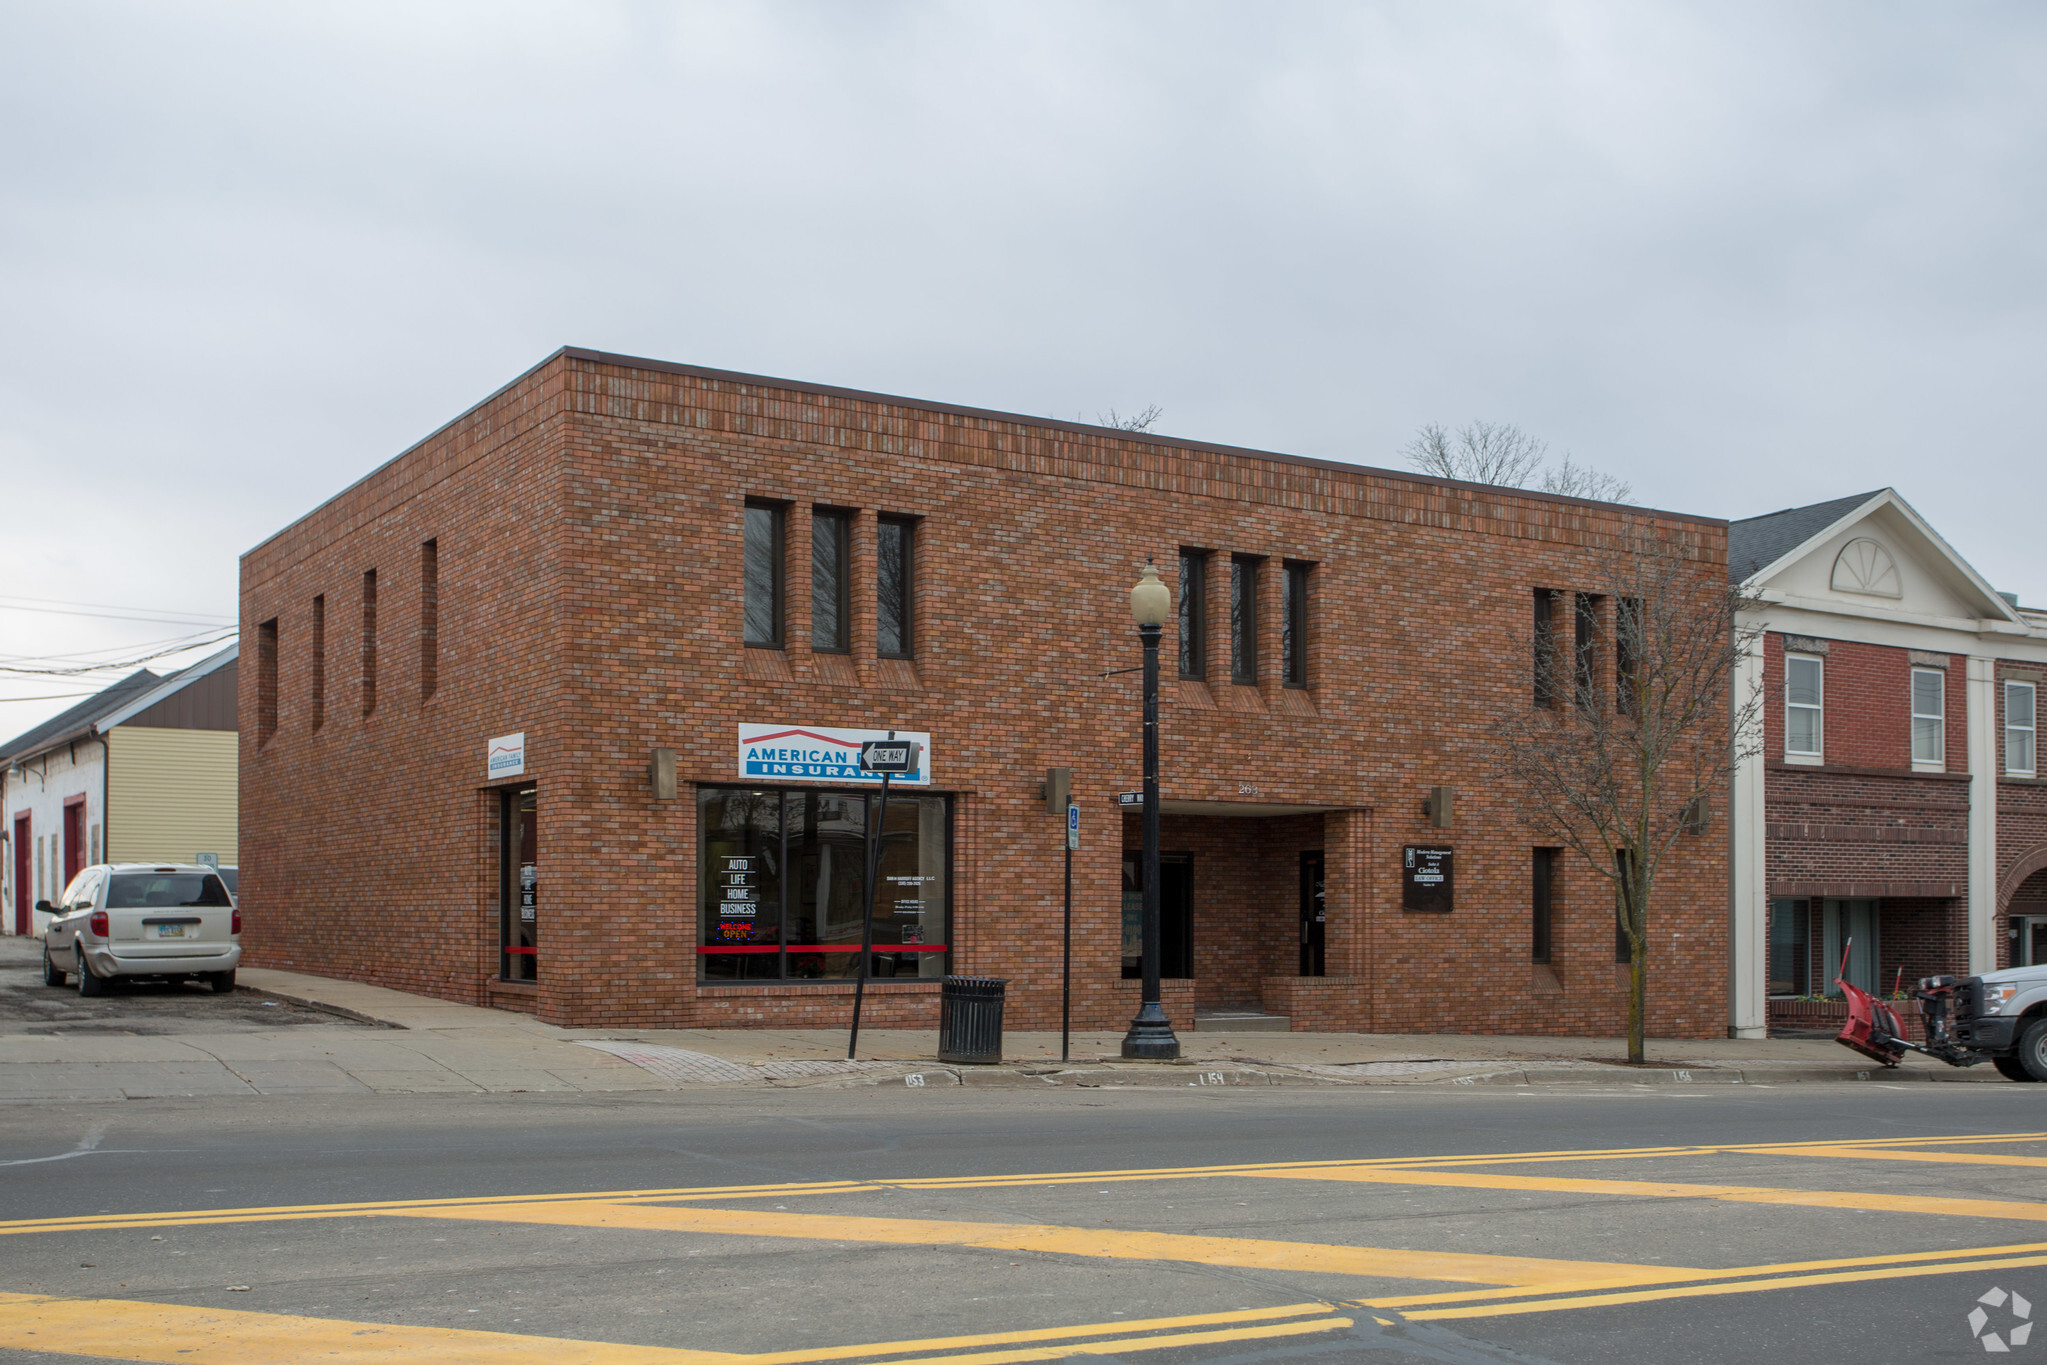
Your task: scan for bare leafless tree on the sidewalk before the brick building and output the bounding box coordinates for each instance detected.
[1490,526,1762,1062]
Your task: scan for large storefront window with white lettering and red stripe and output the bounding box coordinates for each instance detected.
[696,788,952,980]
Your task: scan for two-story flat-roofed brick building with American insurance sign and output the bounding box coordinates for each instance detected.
[242,350,1728,1036]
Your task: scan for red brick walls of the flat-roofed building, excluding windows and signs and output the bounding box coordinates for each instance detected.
[242,354,1726,1036]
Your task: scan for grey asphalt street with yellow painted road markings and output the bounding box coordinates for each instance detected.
[0,1085,2047,1365]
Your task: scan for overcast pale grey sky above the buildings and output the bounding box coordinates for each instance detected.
[0,0,2047,739]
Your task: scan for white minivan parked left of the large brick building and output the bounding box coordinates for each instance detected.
[35,864,242,995]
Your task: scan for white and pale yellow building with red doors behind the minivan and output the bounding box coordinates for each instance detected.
[0,645,237,933]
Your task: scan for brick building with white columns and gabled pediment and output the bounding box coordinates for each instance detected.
[1728,489,2047,1036]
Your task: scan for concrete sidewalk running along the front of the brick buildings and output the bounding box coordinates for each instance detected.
[0,939,2002,1101]
